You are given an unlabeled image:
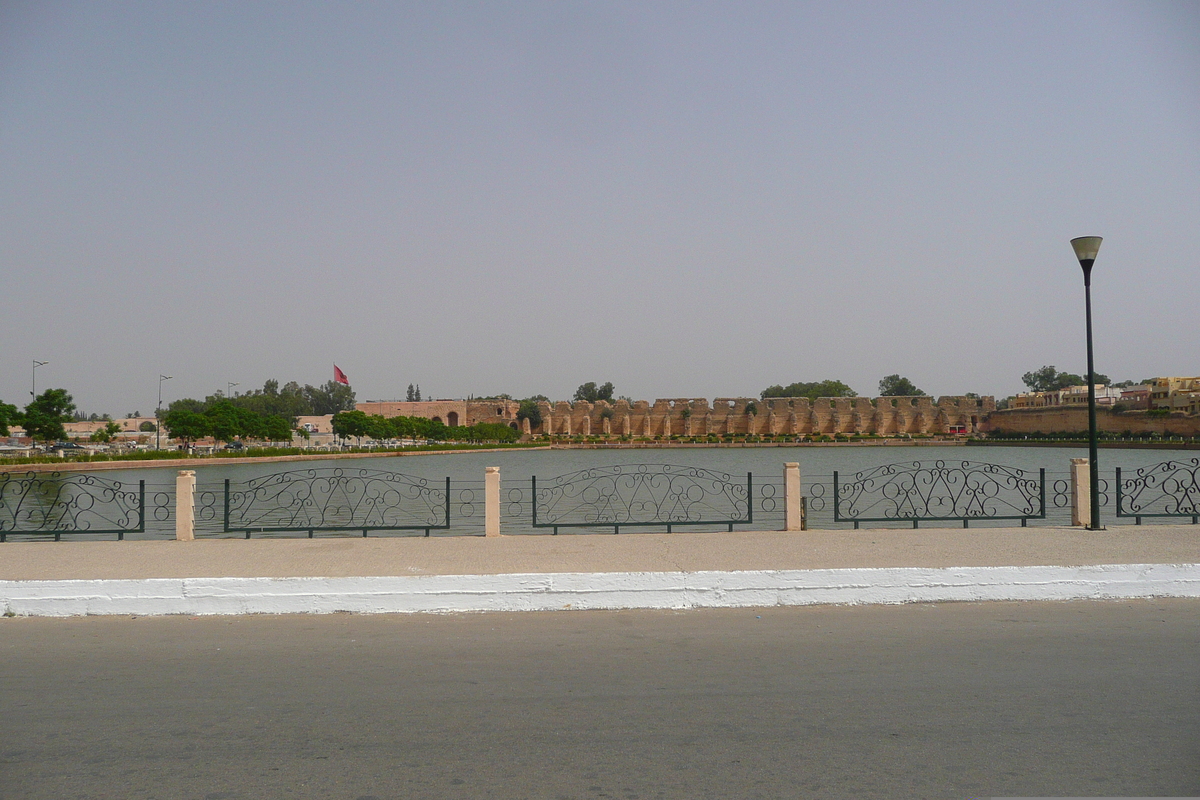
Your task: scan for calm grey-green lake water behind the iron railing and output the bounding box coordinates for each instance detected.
[4,446,1198,540]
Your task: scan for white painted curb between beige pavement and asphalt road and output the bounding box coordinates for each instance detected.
[0,564,1200,616]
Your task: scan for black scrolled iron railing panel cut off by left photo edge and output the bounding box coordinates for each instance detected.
[0,471,146,542]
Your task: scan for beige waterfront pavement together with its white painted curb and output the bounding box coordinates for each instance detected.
[0,525,1200,615]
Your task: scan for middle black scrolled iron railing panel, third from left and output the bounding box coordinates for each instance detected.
[530,464,754,534]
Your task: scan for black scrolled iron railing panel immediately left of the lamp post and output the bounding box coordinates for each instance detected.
[833,461,1046,528]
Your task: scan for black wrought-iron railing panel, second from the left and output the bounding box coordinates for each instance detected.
[220,468,451,539]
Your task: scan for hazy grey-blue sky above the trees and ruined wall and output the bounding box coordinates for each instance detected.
[0,0,1200,415]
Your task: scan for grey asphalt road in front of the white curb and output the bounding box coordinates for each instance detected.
[0,600,1200,800]
